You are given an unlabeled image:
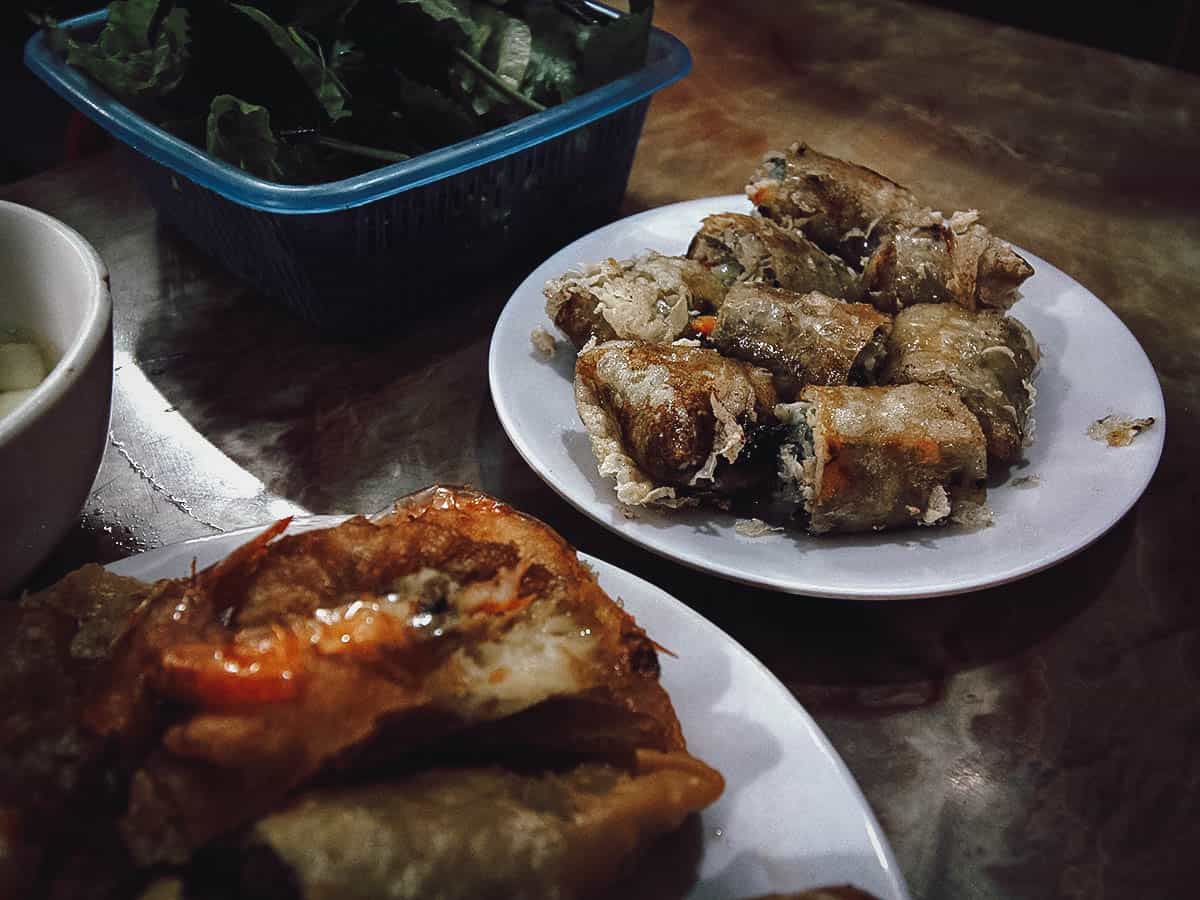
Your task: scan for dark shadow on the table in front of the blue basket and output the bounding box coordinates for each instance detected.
[131,230,523,512]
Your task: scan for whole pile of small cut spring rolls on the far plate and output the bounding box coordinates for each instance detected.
[546,144,1039,536]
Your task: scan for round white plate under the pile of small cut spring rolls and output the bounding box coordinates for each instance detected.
[488,196,1166,599]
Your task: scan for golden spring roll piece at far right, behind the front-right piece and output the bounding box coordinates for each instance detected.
[881,305,1039,462]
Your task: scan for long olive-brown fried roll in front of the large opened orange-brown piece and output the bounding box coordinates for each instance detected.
[240,752,722,900]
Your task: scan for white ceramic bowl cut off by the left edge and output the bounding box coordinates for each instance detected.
[0,202,113,596]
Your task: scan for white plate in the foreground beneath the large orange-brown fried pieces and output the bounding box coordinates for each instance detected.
[108,516,908,900]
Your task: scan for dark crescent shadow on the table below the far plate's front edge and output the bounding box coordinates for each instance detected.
[660,508,1138,715]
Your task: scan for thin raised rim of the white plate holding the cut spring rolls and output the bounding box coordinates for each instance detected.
[487,194,1166,602]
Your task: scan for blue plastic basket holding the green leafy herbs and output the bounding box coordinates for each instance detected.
[25,4,691,334]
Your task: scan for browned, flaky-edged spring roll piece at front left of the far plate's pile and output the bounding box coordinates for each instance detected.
[575,341,779,506]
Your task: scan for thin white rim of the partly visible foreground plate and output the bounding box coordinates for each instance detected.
[104,514,911,900]
